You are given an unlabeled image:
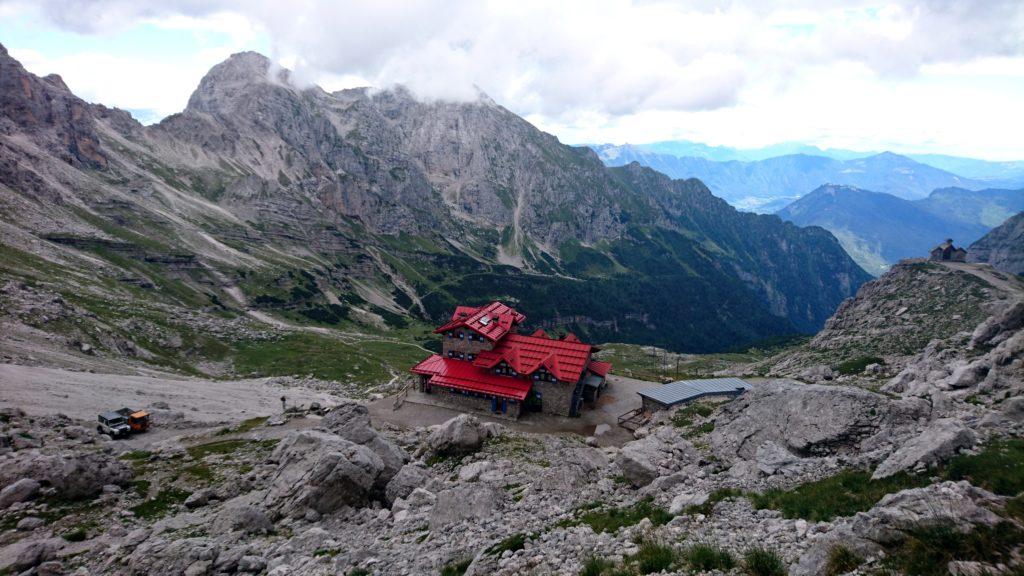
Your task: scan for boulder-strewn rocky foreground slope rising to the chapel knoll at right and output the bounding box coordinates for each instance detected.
[0,253,1024,576]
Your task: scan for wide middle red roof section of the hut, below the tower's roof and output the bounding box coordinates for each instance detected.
[473,334,591,382]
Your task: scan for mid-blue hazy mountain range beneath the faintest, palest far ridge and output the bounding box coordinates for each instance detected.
[594,146,988,212]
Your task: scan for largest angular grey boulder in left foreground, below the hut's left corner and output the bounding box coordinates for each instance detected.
[265,430,393,517]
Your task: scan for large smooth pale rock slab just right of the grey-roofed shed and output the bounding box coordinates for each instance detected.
[711,380,916,462]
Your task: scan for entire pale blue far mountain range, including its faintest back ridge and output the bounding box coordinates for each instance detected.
[591,141,1024,211]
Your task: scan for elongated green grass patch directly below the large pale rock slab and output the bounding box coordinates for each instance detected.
[748,470,928,522]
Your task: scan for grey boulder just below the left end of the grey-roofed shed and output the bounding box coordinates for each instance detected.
[615,426,698,488]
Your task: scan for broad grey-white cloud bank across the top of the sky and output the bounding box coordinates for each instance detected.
[22,0,1024,116]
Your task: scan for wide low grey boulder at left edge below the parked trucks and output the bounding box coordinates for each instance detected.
[0,452,132,498]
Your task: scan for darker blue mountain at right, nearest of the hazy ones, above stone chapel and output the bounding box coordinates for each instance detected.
[778,184,1024,275]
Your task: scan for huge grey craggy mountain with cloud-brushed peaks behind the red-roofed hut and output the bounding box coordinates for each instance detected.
[0,45,869,358]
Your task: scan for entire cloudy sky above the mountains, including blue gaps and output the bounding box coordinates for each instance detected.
[6,0,1024,160]
